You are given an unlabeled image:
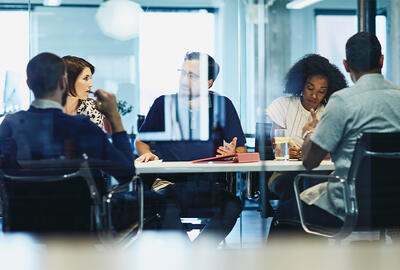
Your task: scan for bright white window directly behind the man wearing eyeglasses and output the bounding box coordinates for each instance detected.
[139,9,214,115]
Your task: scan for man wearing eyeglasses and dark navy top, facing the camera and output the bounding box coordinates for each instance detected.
[135,52,246,244]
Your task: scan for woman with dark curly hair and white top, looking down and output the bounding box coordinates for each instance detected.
[267,54,347,200]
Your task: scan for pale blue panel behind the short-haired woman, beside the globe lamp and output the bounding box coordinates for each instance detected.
[30,5,139,131]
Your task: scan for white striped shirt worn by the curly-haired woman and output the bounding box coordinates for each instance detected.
[266,97,325,146]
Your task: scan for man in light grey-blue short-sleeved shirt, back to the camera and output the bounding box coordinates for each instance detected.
[301,32,400,220]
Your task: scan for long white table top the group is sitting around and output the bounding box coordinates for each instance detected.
[135,160,335,174]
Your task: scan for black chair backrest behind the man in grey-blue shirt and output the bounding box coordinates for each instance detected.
[348,133,400,230]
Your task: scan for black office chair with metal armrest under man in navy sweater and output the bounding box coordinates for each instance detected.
[0,155,143,244]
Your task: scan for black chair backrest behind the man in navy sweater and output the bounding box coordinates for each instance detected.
[0,159,106,234]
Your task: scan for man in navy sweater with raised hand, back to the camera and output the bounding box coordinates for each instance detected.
[0,53,181,230]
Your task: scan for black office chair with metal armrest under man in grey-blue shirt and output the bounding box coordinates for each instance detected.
[294,133,400,238]
